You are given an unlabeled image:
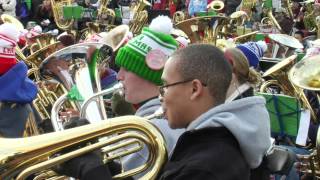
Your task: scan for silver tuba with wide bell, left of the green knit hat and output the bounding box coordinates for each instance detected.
[40,42,113,131]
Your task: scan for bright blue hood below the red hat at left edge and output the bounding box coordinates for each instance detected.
[0,62,38,103]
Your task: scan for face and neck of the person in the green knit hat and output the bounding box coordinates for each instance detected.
[117,67,159,104]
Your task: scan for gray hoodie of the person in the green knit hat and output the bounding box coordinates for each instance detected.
[122,98,185,176]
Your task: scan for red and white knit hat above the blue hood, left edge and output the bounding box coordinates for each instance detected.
[0,23,20,75]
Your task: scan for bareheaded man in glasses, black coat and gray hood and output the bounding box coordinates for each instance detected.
[159,44,270,180]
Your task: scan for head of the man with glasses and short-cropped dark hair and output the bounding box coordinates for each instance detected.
[159,45,231,129]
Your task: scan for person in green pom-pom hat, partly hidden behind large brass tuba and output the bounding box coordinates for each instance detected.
[56,16,184,180]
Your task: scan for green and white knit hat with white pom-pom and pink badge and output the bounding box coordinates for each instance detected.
[116,16,178,85]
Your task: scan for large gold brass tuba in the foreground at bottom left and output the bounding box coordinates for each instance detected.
[0,116,167,180]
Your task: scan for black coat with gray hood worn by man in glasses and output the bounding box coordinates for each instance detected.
[159,97,271,180]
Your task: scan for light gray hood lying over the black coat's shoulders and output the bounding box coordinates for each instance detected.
[187,97,271,169]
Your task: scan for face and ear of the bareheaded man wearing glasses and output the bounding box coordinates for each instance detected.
[160,58,212,129]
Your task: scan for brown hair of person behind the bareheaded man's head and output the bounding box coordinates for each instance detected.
[224,48,261,84]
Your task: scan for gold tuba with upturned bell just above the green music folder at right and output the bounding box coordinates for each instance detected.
[260,54,317,122]
